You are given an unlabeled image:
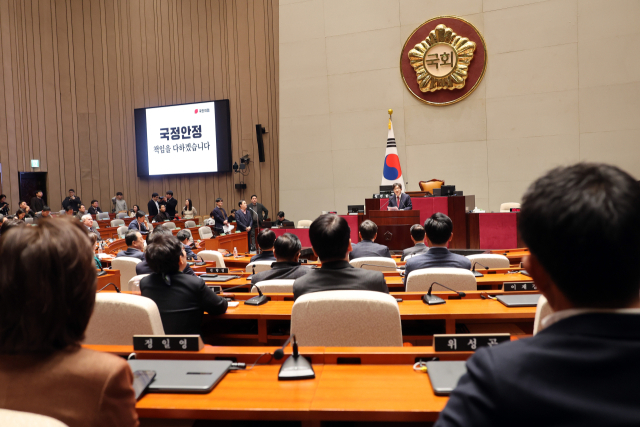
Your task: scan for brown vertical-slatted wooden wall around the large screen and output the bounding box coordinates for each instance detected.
[0,0,279,221]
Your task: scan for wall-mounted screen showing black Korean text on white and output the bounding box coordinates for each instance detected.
[134,99,231,176]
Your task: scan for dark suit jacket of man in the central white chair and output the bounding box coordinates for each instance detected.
[293,261,389,299]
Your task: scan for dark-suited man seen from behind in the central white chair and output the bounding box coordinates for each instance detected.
[293,214,389,298]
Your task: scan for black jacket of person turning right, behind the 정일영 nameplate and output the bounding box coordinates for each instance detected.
[140,272,227,335]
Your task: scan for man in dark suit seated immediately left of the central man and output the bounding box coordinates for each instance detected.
[251,233,311,285]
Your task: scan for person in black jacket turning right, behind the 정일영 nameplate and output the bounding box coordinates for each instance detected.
[140,234,227,335]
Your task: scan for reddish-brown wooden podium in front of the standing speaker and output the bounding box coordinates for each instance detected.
[369,210,420,250]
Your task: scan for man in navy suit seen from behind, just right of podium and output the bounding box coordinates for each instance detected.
[404,212,471,285]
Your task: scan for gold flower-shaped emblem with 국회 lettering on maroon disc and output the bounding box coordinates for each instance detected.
[409,24,476,92]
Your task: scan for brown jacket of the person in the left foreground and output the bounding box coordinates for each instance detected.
[0,348,138,427]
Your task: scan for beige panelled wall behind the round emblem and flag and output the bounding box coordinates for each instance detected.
[280,0,640,224]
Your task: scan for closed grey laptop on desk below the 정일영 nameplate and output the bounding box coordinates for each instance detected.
[129,360,231,393]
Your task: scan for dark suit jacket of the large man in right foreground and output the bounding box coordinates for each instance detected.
[436,313,640,427]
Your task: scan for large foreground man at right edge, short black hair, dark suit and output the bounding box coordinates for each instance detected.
[438,163,640,427]
